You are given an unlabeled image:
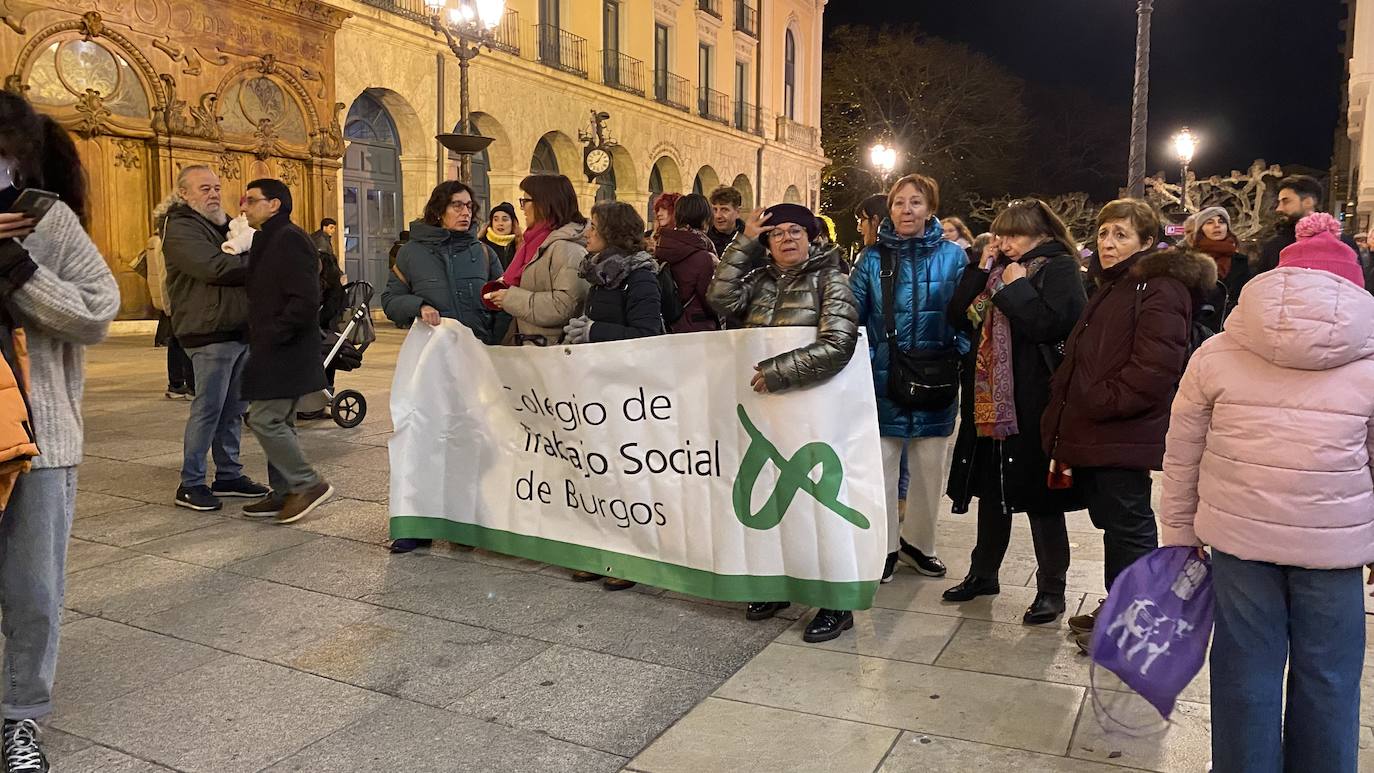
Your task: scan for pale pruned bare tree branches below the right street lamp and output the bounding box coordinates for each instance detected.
[1145,158,1283,242]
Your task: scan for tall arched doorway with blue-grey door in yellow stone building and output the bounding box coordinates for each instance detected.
[344,92,405,302]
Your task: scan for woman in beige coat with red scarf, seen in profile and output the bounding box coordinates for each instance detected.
[482,174,587,346]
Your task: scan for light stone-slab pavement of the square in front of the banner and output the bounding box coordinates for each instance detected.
[37,328,1374,773]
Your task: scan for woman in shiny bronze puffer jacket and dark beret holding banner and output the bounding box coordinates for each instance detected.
[706,199,859,641]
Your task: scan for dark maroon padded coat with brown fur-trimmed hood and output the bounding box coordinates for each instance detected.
[1040,249,1216,470]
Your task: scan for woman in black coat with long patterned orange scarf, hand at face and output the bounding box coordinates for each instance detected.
[944,199,1087,625]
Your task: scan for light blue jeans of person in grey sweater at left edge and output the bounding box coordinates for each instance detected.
[0,467,77,719]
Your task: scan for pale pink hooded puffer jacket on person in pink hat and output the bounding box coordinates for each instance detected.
[1160,268,1374,568]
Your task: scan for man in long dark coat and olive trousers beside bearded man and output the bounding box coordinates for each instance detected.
[243,180,334,523]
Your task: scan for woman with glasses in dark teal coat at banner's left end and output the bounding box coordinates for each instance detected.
[382,180,510,553]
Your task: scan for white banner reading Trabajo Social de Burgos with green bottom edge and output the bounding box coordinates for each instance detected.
[390,320,888,610]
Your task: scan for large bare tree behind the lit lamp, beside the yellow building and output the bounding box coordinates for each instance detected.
[822,26,1026,238]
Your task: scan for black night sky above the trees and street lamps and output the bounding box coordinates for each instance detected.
[826,0,1345,177]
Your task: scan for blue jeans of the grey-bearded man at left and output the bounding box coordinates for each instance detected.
[181,341,249,486]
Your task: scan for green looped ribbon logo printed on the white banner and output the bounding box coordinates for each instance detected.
[734,405,868,531]
